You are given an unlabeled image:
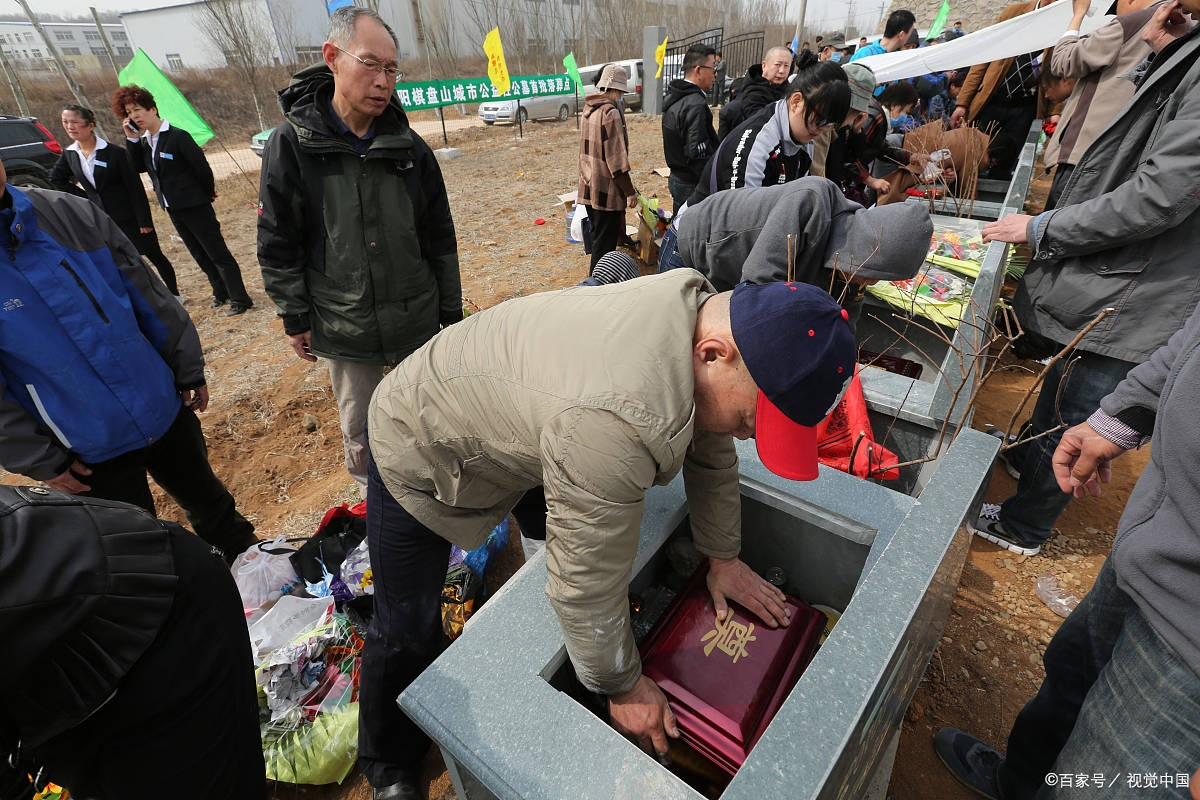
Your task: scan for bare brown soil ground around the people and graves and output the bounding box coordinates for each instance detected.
[5,115,1146,800]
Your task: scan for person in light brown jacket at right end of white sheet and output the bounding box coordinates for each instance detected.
[1042,0,1165,211]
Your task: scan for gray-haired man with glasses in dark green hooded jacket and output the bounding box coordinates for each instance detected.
[258,6,462,496]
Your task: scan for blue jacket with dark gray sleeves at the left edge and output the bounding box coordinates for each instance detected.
[0,186,204,480]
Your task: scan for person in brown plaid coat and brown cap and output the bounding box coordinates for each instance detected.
[578,64,637,269]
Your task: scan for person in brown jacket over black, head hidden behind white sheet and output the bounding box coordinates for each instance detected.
[950,0,1062,180]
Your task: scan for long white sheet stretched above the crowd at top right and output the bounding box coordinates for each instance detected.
[854,0,1112,83]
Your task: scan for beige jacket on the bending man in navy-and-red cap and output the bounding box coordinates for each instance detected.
[368,270,742,694]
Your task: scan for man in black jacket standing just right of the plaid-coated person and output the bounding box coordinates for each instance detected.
[662,44,716,211]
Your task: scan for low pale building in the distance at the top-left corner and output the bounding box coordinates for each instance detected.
[0,22,133,72]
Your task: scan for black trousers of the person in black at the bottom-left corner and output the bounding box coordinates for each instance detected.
[34,529,266,800]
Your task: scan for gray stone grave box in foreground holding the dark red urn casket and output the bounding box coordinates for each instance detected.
[398,431,1000,800]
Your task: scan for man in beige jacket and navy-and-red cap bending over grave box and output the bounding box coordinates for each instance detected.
[359,269,856,796]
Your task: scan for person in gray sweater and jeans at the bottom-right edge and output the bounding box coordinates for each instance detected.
[934,302,1200,800]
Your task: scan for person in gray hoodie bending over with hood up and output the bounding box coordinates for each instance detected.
[659,176,934,296]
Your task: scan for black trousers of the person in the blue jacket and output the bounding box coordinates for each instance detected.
[76,408,258,558]
